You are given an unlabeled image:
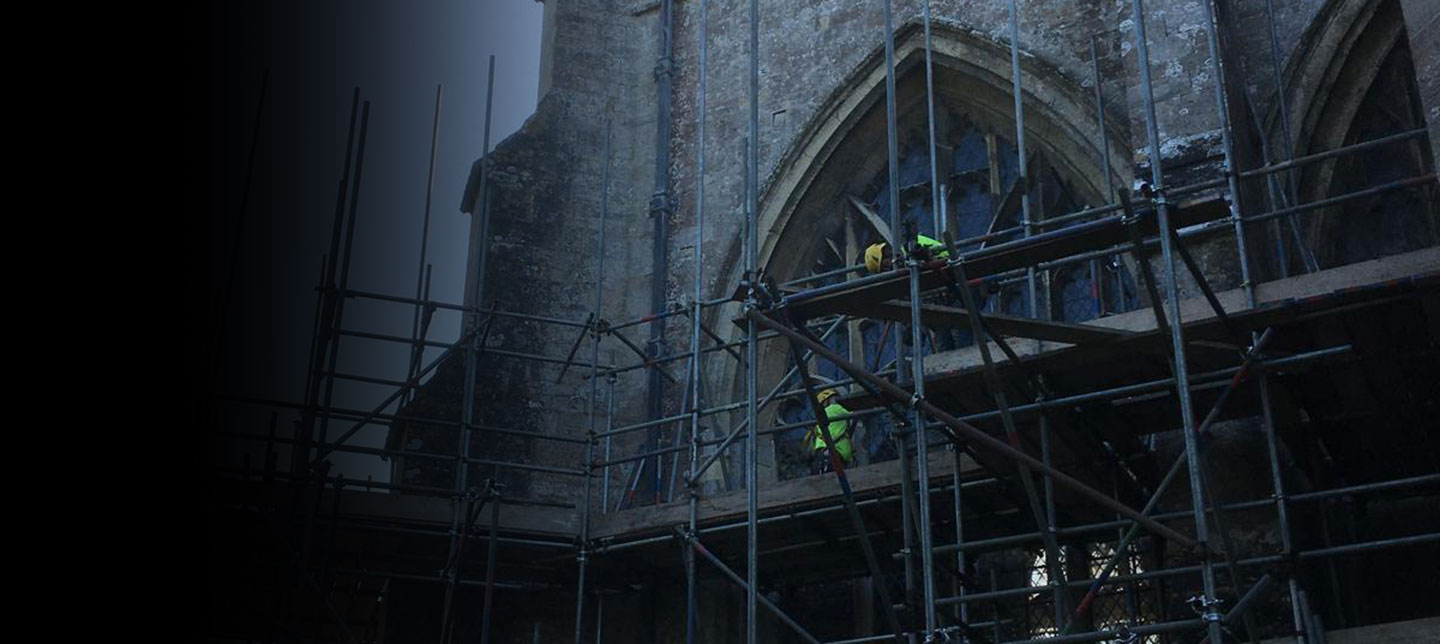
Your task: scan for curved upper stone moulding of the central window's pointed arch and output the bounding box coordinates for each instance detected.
[736,23,1129,282]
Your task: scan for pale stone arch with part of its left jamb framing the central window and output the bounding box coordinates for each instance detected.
[696,23,1130,478]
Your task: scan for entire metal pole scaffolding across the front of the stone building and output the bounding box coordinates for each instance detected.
[205,0,1440,644]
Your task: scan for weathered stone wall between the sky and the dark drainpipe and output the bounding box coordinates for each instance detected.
[410,1,668,503]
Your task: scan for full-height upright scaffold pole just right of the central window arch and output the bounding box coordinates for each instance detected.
[1132,0,1224,643]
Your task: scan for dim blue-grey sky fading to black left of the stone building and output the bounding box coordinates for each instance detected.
[197,0,543,480]
